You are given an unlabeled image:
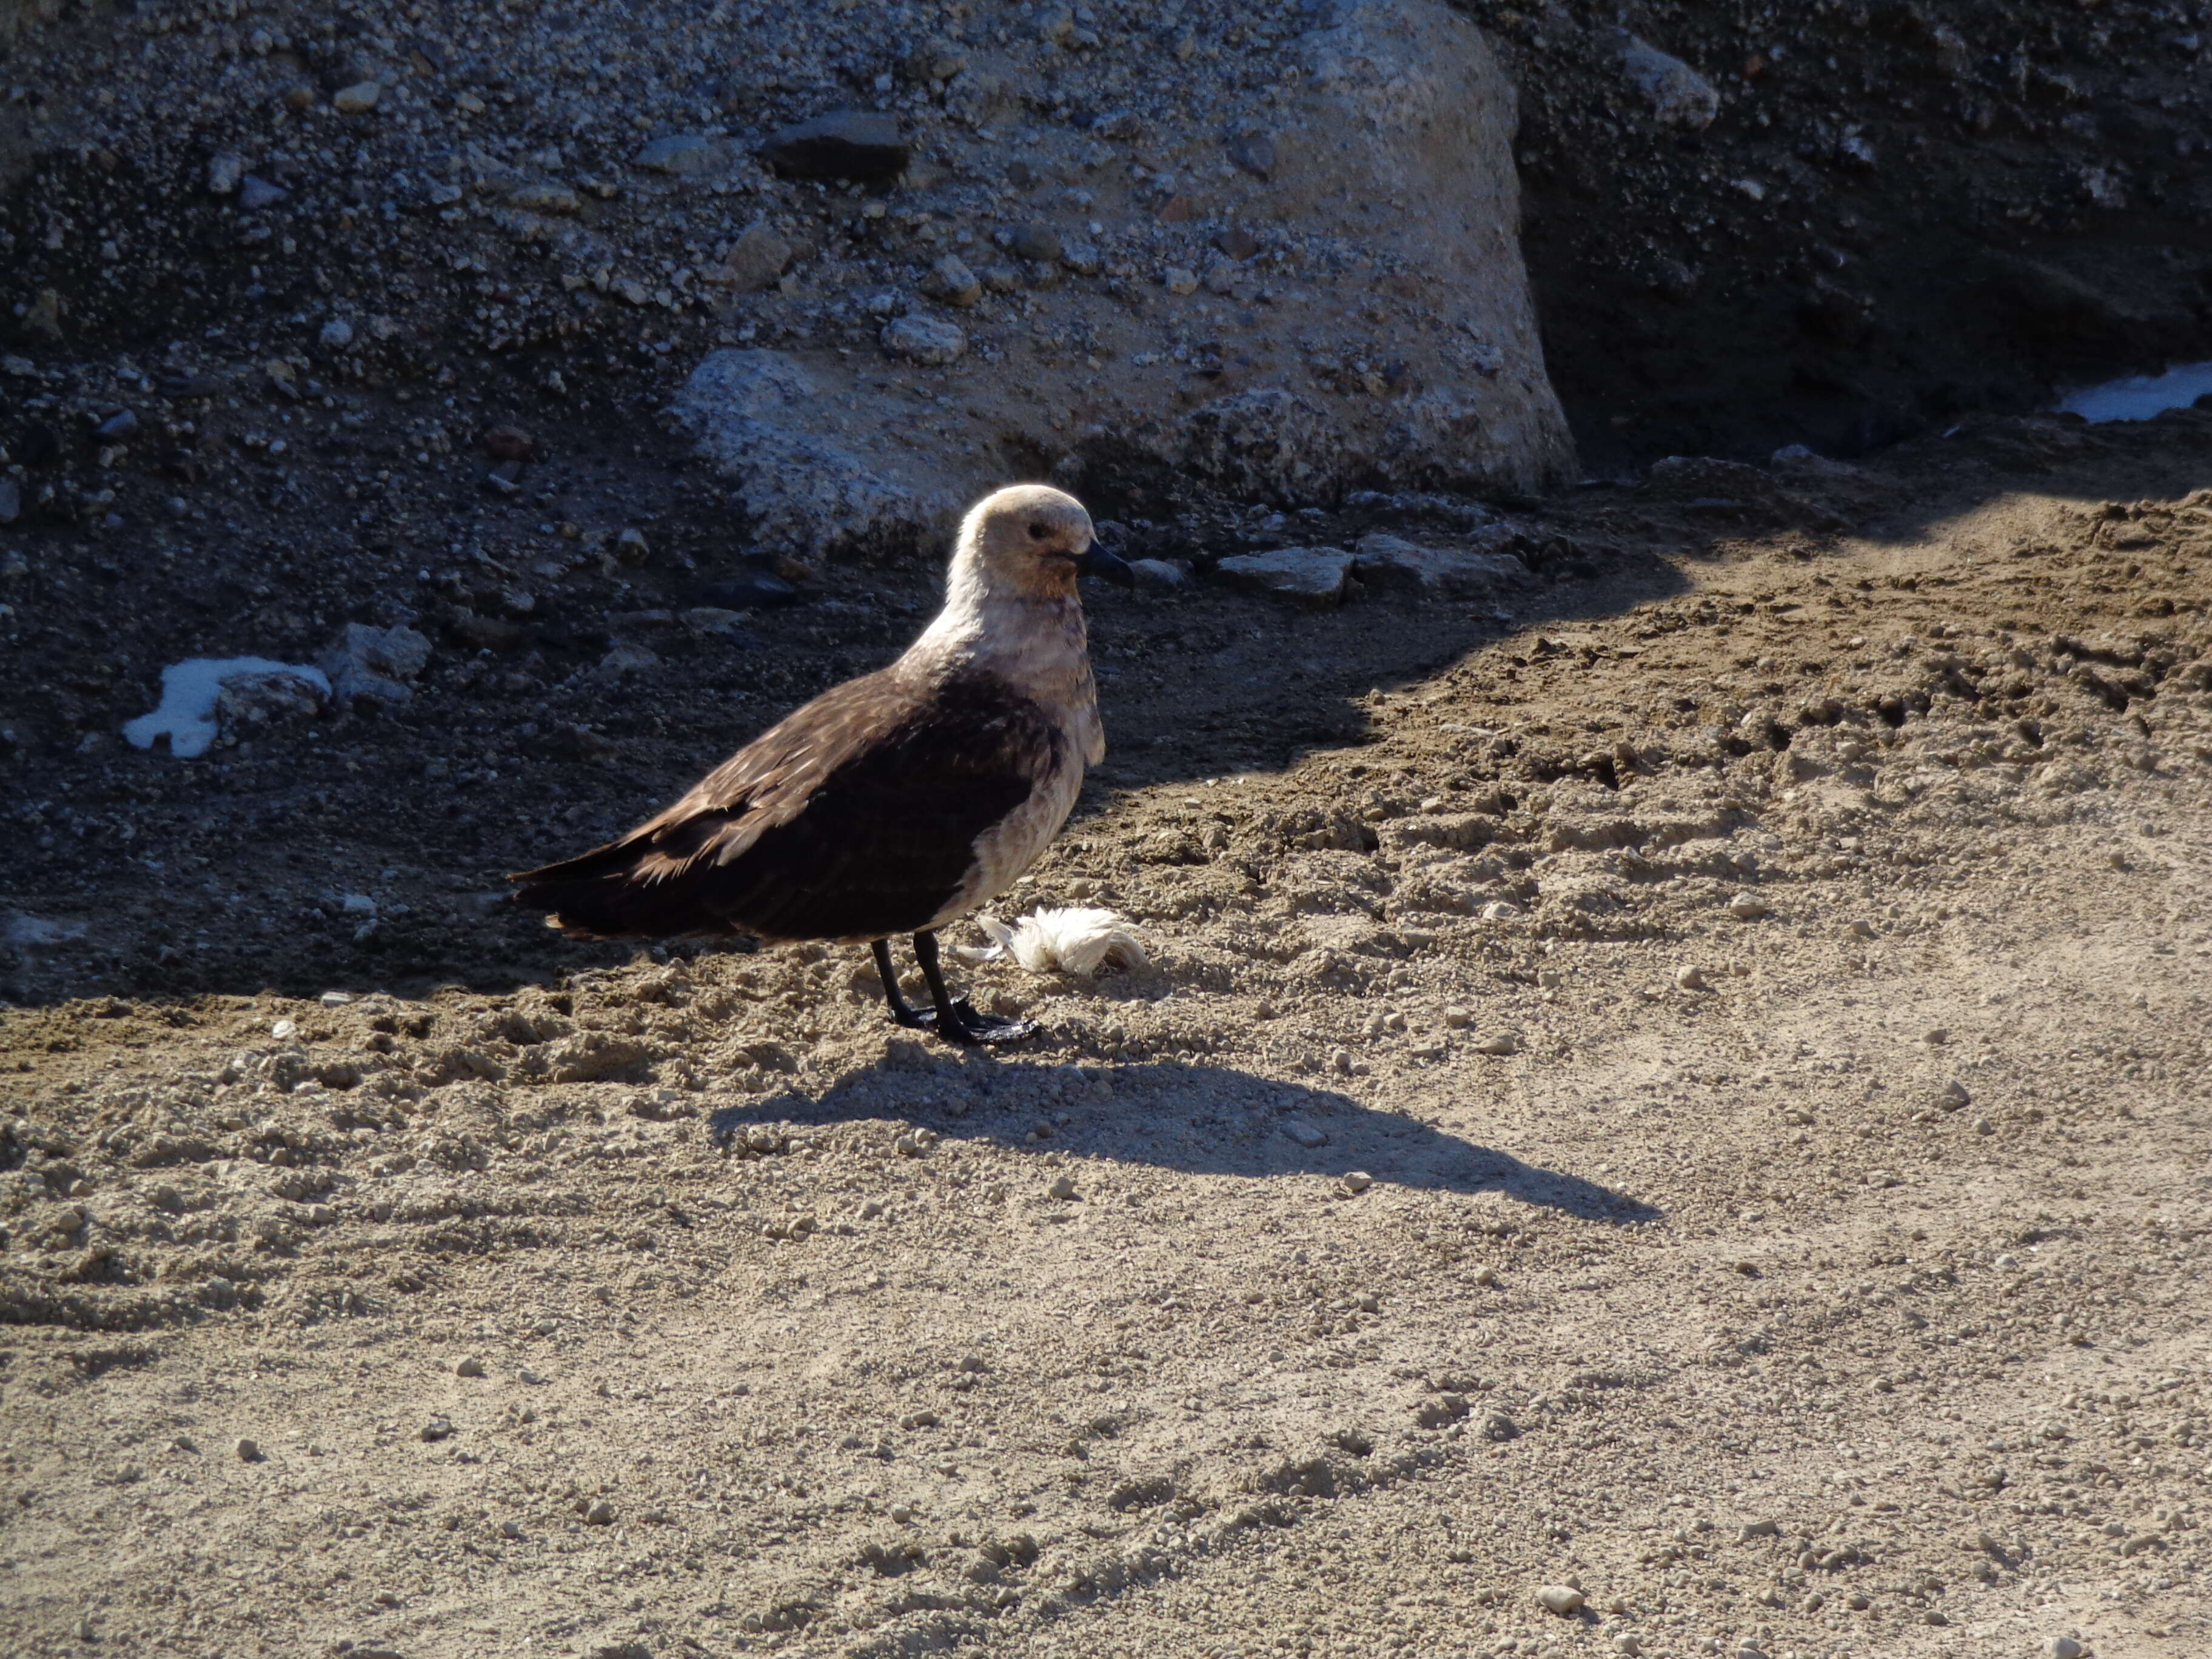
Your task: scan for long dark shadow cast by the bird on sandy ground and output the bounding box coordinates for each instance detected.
[708,1044,1661,1225]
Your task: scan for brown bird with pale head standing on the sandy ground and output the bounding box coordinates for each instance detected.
[509,484,1134,1044]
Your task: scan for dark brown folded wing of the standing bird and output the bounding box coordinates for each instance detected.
[511,670,1068,938]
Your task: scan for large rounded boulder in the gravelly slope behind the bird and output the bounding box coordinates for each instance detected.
[675,0,1575,551]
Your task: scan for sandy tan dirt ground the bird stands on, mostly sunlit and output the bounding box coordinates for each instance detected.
[0,412,2212,1659]
